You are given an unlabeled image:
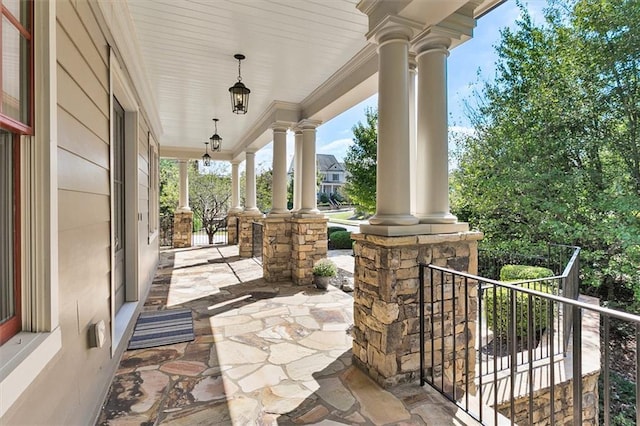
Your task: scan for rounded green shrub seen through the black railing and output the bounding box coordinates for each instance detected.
[483,265,554,339]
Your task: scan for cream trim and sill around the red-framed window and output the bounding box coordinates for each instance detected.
[0,1,62,424]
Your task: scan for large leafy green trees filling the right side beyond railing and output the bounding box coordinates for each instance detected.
[452,0,640,300]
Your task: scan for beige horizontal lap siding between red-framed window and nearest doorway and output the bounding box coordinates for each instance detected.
[3,1,117,425]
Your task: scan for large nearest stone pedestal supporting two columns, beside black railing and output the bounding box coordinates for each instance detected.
[352,232,482,387]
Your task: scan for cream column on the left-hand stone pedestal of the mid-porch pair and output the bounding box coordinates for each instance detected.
[269,123,290,216]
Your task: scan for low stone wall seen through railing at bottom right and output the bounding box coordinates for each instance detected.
[498,371,600,426]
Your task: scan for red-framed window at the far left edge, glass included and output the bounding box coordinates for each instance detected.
[0,0,33,345]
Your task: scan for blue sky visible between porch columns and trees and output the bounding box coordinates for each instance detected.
[251,0,547,169]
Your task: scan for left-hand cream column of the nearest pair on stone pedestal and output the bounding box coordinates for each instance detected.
[369,26,418,226]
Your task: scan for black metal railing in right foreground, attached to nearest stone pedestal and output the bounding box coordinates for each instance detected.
[419,260,640,425]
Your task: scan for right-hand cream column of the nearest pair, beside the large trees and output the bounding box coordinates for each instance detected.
[416,37,457,223]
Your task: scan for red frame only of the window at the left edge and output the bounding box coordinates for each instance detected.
[0,0,34,345]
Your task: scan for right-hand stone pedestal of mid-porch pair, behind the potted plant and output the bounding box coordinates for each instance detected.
[291,217,328,285]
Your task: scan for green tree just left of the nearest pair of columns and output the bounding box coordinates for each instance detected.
[344,108,378,214]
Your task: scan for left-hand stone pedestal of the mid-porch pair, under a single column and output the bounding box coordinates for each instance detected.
[262,217,292,282]
